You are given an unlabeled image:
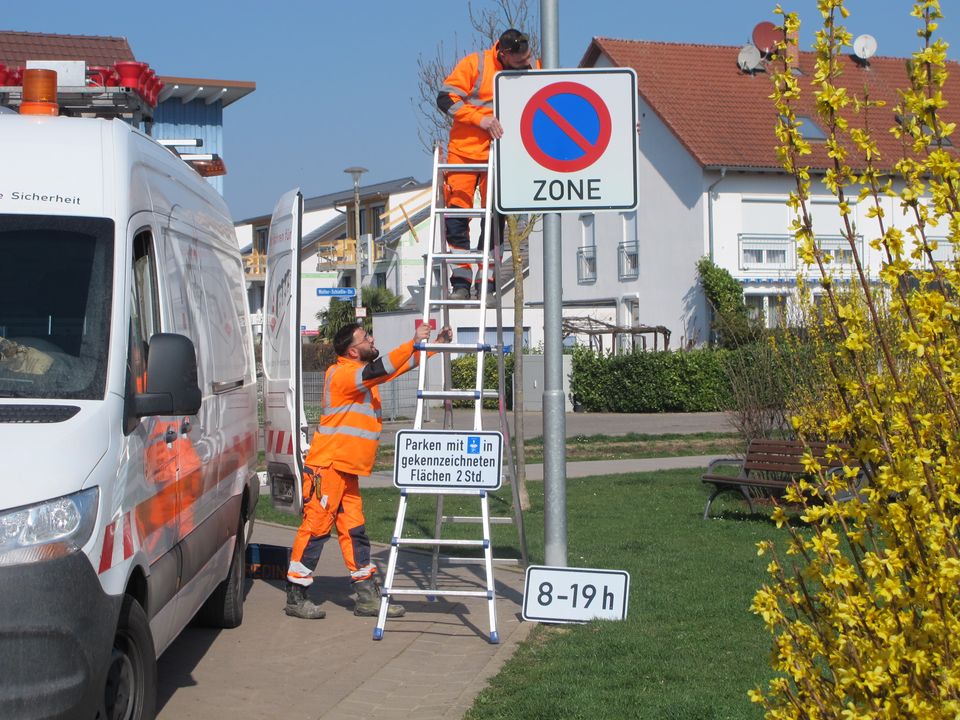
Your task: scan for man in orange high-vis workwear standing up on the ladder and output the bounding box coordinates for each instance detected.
[437,28,540,300]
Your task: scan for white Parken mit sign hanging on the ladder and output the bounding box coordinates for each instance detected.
[393,430,503,490]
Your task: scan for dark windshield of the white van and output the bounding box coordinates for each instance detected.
[0,215,114,400]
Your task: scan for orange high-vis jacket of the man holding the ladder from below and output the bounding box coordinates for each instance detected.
[304,340,420,475]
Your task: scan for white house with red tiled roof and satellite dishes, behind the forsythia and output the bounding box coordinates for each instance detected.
[528,37,960,348]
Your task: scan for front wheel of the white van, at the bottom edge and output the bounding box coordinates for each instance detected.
[97,595,157,720]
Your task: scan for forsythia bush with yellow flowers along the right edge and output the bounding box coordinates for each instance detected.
[750,0,960,720]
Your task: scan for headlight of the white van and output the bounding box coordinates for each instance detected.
[0,487,100,565]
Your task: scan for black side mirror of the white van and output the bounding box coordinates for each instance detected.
[133,333,203,417]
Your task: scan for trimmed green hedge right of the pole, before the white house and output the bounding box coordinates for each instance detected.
[570,347,733,413]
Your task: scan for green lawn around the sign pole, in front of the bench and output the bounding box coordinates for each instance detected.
[260,470,778,720]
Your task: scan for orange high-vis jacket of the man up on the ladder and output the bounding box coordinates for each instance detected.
[437,46,540,162]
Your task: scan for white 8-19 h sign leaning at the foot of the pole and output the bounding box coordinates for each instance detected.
[523,565,630,623]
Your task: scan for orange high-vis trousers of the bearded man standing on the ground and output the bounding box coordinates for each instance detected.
[287,466,376,586]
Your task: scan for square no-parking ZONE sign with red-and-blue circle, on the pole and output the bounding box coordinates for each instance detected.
[494,68,637,213]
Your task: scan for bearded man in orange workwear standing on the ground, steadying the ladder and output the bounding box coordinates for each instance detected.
[284,324,452,620]
